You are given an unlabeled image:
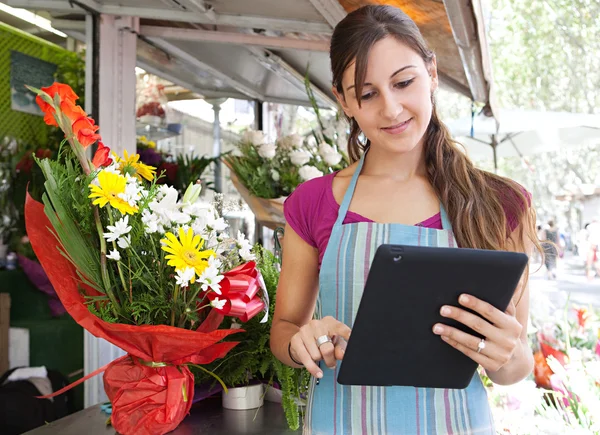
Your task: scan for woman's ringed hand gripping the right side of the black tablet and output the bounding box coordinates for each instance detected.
[433,294,523,372]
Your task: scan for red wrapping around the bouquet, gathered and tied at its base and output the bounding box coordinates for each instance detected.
[25,195,248,435]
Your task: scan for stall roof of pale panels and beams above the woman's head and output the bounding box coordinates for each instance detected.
[7,0,491,106]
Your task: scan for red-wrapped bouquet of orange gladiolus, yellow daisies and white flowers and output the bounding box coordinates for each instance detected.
[25,83,269,435]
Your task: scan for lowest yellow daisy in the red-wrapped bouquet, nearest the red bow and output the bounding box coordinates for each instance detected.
[161,228,216,282]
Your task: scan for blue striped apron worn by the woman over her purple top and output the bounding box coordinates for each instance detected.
[304,155,495,435]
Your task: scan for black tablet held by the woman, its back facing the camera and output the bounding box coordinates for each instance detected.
[337,245,528,389]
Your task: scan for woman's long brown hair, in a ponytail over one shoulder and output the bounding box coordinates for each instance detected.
[330,5,542,292]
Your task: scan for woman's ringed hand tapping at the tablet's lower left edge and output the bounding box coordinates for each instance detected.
[290,316,351,378]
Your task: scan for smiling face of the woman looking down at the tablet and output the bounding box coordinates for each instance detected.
[334,36,437,157]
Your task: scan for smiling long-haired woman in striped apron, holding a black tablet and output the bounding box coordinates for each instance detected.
[271,6,539,435]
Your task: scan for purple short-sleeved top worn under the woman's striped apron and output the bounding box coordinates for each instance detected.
[284,172,531,267]
